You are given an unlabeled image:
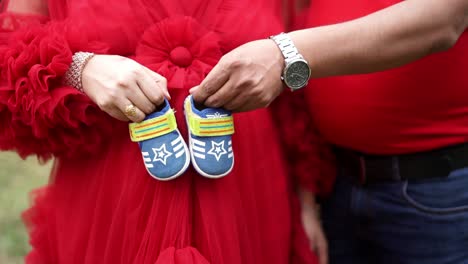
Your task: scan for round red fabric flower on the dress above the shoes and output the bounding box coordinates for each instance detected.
[136,16,222,89]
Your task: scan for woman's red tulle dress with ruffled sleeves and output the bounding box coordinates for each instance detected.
[0,0,334,264]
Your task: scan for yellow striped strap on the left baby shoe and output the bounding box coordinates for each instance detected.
[129,109,177,142]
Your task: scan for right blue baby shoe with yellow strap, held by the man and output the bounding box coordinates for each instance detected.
[184,96,234,179]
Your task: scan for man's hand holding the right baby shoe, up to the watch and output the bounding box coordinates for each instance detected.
[190,39,284,112]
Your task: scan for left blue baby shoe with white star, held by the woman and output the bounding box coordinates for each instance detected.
[129,100,190,181]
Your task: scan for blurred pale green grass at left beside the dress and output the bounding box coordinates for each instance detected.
[0,152,51,264]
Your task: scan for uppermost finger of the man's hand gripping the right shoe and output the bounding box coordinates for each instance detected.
[192,61,230,103]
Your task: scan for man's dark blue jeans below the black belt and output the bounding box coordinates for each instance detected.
[322,168,468,264]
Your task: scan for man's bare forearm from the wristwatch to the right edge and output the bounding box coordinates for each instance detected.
[290,0,468,78]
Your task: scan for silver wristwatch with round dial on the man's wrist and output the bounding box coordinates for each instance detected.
[270,33,310,91]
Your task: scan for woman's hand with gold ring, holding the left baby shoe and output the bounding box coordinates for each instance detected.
[82,55,170,122]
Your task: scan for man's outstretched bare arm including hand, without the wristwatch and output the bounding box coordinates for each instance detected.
[192,0,468,111]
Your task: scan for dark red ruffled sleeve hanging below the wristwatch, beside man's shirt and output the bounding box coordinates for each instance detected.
[272,91,336,196]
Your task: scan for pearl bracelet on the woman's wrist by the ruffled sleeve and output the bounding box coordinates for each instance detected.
[63,52,94,92]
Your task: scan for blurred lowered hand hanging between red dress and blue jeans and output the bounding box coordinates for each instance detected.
[299,190,328,264]
